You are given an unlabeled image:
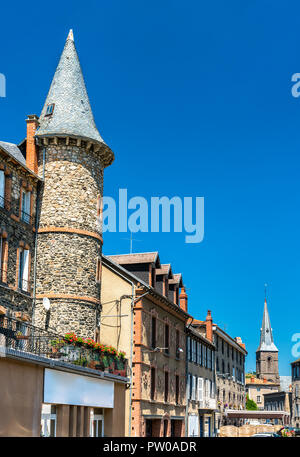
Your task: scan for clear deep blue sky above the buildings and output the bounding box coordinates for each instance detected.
[0,0,300,375]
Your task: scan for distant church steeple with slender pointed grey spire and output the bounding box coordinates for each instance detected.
[256,300,280,384]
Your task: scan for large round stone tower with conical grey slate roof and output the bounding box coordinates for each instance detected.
[34,30,114,338]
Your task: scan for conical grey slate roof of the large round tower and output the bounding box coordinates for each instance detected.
[36,30,110,148]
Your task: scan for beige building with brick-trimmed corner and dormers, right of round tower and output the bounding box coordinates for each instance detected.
[100,253,188,436]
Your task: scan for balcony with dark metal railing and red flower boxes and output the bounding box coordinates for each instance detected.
[0,315,128,377]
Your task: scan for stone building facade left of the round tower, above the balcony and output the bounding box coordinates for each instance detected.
[0,142,41,321]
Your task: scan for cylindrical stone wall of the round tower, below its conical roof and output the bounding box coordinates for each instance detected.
[35,138,103,338]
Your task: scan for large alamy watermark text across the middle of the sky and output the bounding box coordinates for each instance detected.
[97,189,204,243]
